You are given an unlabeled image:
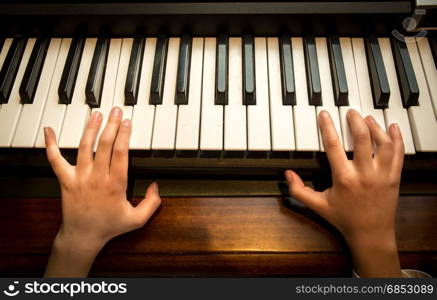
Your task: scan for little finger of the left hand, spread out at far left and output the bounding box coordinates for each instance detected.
[44,127,71,180]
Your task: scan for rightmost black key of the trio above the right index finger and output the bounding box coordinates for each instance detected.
[328,37,349,106]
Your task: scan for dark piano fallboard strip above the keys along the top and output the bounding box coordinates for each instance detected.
[0,0,413,37]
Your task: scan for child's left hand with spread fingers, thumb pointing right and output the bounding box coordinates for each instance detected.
[44,108,161,276]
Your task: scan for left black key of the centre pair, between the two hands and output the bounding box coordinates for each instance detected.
[215,34,228,105]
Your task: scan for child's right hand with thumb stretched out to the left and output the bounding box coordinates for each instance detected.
[286,110,404,277]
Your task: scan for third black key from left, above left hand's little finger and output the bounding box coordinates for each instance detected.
[58,38,85,104]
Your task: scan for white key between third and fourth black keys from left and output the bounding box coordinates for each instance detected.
[59,38,97,148]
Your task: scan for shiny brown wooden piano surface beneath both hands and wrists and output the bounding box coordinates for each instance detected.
[0,195,437,277]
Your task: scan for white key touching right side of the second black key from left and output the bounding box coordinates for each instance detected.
[12,38,62,148]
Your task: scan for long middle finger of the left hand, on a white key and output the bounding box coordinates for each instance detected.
[94,107,123,173]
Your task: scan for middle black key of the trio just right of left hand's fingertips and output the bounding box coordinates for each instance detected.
[150,36,168,105]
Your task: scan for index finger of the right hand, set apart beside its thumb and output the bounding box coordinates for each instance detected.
[319,110,348,173]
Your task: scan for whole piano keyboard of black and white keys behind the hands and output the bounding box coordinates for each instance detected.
[0,35,437,156]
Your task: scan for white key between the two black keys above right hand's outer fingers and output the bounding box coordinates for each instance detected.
[378,38,416,154]
